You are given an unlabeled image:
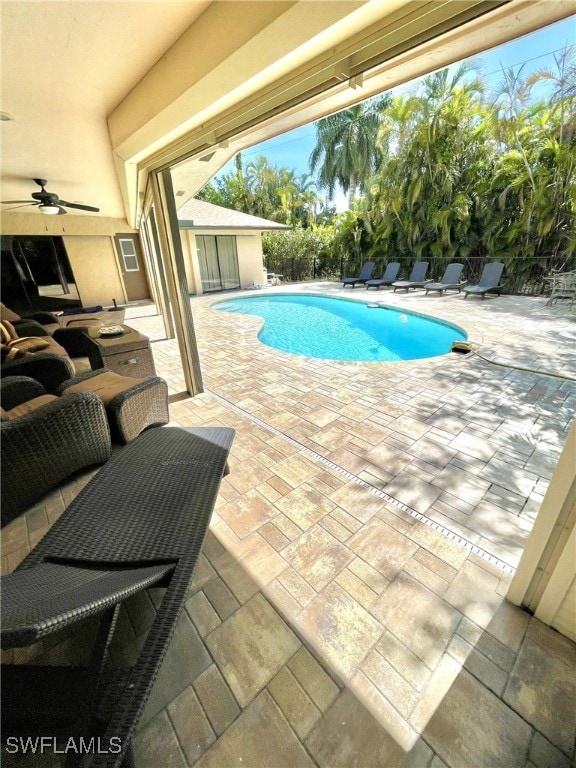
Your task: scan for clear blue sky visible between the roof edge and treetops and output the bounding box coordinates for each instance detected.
[218,17,576,210]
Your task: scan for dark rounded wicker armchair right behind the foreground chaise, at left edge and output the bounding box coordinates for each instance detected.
[0,376,112,526]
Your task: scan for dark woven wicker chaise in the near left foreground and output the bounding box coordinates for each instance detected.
[1,426,234,768]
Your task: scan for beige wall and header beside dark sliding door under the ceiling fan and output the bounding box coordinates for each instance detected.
[2,211,134,307]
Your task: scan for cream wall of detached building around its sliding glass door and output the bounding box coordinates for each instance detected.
[180,228,264,296]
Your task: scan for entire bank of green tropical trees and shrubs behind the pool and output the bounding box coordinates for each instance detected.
[197,48,576,290]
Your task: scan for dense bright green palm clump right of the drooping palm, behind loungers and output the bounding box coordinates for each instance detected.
[365,50,576,281]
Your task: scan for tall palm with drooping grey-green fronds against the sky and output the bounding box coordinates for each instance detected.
[310,96,390,207]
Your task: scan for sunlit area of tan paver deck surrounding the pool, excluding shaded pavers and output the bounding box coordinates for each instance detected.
[132,283,576,760]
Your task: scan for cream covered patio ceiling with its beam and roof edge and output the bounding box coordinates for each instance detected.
[0,0,575,226]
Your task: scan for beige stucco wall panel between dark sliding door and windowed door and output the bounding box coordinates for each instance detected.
[63,236,126,307]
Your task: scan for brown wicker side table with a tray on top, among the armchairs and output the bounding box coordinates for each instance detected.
[85,325,156,378]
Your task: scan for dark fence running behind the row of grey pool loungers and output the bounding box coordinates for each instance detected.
[266,255,576,296]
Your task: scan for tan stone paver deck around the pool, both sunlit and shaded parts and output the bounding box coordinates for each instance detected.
[4,284,576,768]
